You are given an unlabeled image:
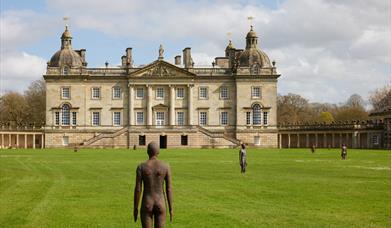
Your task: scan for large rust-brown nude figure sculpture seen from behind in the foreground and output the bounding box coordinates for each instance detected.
[133,142,173,228]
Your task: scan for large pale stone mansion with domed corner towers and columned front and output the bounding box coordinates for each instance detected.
[43,27,280,148]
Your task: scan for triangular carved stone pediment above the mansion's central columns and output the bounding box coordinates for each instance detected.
[129,60,196,78]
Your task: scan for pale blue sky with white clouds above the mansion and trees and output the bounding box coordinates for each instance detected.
[0,0,391,103]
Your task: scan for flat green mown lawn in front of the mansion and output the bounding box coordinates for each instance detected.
[0,149,391,227]
